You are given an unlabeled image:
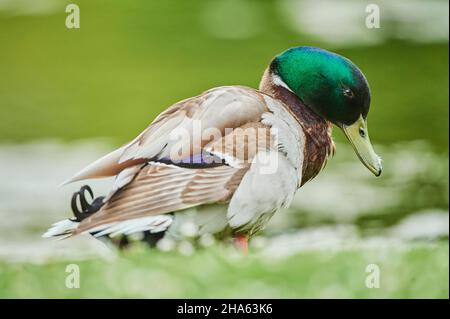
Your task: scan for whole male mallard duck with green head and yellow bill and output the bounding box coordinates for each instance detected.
[44,47,382,251]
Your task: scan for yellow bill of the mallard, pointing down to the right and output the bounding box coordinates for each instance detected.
[342,116,383,176]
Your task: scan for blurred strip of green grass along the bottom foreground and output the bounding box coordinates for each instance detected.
[0,241,449,298]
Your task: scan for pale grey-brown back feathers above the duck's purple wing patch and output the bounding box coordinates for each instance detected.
[64,86,267,184]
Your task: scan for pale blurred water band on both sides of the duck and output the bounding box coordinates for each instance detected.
[0,139,449,261]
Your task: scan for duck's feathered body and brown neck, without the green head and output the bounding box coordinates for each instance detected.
[45,47,381,248]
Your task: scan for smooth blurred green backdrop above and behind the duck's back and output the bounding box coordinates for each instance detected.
[0,0,448,151]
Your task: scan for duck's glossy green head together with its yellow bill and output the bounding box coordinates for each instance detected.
[270,47,381,176]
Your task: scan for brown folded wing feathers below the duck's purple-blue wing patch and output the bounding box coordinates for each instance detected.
[73,162,248,234]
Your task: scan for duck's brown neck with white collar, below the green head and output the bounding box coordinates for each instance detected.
[259,68,335,185]
